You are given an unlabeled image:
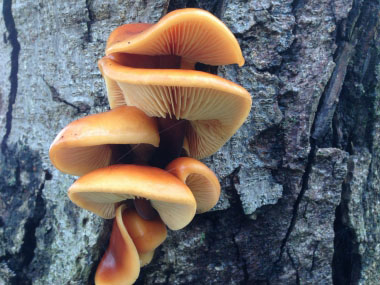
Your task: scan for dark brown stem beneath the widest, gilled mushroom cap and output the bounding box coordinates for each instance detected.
[150,118,188,168]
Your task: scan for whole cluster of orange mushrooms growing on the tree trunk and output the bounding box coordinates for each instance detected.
[49,9,251,284]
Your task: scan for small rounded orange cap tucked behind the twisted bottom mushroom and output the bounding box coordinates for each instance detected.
[123,206,167,255]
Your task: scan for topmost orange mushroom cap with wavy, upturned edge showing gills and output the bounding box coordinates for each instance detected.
[106,8,244,66]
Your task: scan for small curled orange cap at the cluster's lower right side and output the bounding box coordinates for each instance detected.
[166,157,220,214]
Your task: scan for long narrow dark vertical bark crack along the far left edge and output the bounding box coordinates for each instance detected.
[1,0,20,153]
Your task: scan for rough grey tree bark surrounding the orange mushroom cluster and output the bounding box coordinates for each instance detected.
[0,0,380,284]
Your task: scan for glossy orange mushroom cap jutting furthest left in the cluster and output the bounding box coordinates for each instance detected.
[49,106,160,176]
